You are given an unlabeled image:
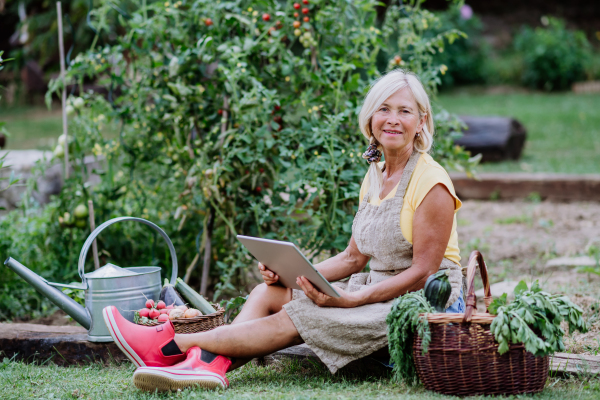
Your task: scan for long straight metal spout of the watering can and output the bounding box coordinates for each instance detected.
[4,257,92,330]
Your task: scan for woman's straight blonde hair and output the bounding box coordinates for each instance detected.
[358,69,435,199]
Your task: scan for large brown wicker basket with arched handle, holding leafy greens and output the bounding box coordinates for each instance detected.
[413,251,549,396]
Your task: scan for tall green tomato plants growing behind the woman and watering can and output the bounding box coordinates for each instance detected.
[0,0,476,318]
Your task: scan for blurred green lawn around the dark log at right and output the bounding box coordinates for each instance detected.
[438,90,600,174]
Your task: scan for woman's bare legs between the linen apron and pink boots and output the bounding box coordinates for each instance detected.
[175,283,303,370]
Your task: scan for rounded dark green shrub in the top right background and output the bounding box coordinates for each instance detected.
[514,17,591,91]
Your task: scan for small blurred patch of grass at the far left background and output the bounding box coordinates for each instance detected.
[0,106,62,150]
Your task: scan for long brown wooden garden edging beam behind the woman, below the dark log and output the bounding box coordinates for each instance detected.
[450,173,600,201]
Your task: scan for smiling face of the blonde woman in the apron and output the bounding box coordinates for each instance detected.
[371,87,427,151]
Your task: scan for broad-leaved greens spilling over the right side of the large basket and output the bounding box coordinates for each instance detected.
[490,281,588,356]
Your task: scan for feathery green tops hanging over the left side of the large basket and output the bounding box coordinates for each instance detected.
[386,290,435,384]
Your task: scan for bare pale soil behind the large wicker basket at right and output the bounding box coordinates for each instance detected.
[457,200,600,355]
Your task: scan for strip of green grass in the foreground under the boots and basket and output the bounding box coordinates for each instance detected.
[0,360,600,400]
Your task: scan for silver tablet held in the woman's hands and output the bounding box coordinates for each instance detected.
[237,235,340,297]
